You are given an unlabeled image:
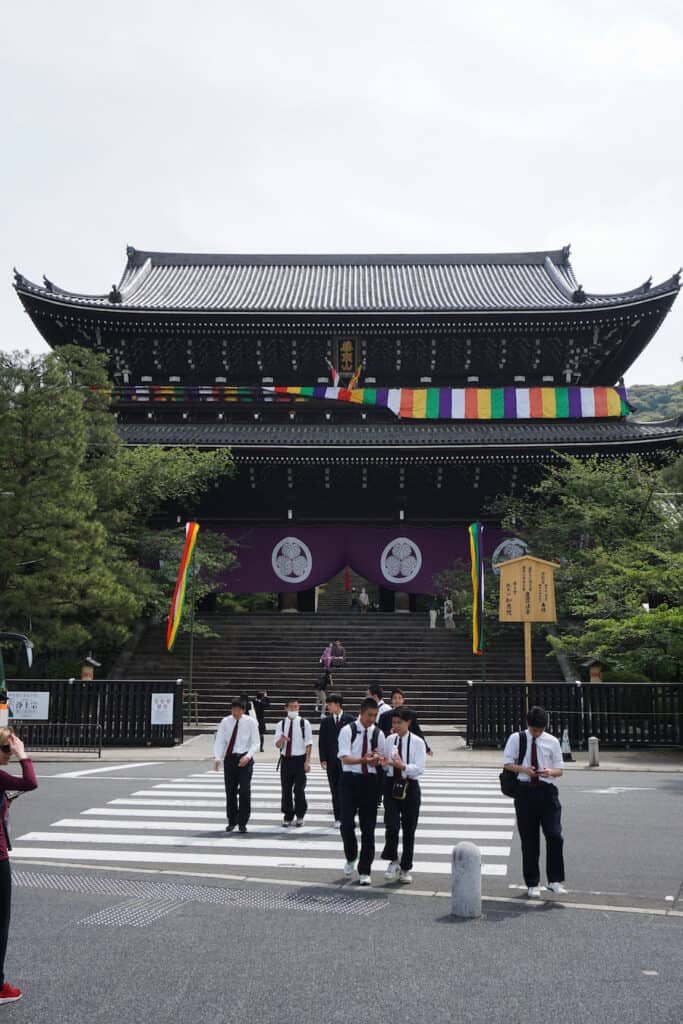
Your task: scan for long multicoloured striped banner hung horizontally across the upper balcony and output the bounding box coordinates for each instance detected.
[98,384,633,420]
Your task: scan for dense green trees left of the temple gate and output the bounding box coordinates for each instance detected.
[0,346,233,655]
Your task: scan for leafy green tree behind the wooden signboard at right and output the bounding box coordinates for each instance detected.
[498,456,683,679]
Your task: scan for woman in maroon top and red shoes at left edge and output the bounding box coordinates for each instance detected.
[0,728,38,1005]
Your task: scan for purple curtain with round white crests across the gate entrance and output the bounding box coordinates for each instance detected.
[216,523,505,594]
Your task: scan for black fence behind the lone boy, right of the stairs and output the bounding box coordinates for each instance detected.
[467,683,683,750]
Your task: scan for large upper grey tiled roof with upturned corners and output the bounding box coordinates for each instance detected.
[15,248,679,313]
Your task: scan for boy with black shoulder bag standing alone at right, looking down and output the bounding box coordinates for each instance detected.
[503,708,566,898]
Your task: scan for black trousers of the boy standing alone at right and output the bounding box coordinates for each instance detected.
[515,782,564,886]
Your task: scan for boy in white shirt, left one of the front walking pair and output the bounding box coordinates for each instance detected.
[339,697,384,886]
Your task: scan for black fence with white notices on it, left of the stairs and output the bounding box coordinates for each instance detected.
[7,679,183,750]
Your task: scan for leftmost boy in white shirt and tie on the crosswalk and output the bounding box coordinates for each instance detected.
[213,697,260,835]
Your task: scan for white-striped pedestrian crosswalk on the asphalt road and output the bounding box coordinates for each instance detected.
[12,764,514,879]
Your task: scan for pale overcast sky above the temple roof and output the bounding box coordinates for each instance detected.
[0,0,683,384]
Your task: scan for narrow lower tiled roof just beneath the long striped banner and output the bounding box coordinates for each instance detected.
[119,420,683,452]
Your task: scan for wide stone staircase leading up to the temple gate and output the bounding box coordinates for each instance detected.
[120,612,562,732]
